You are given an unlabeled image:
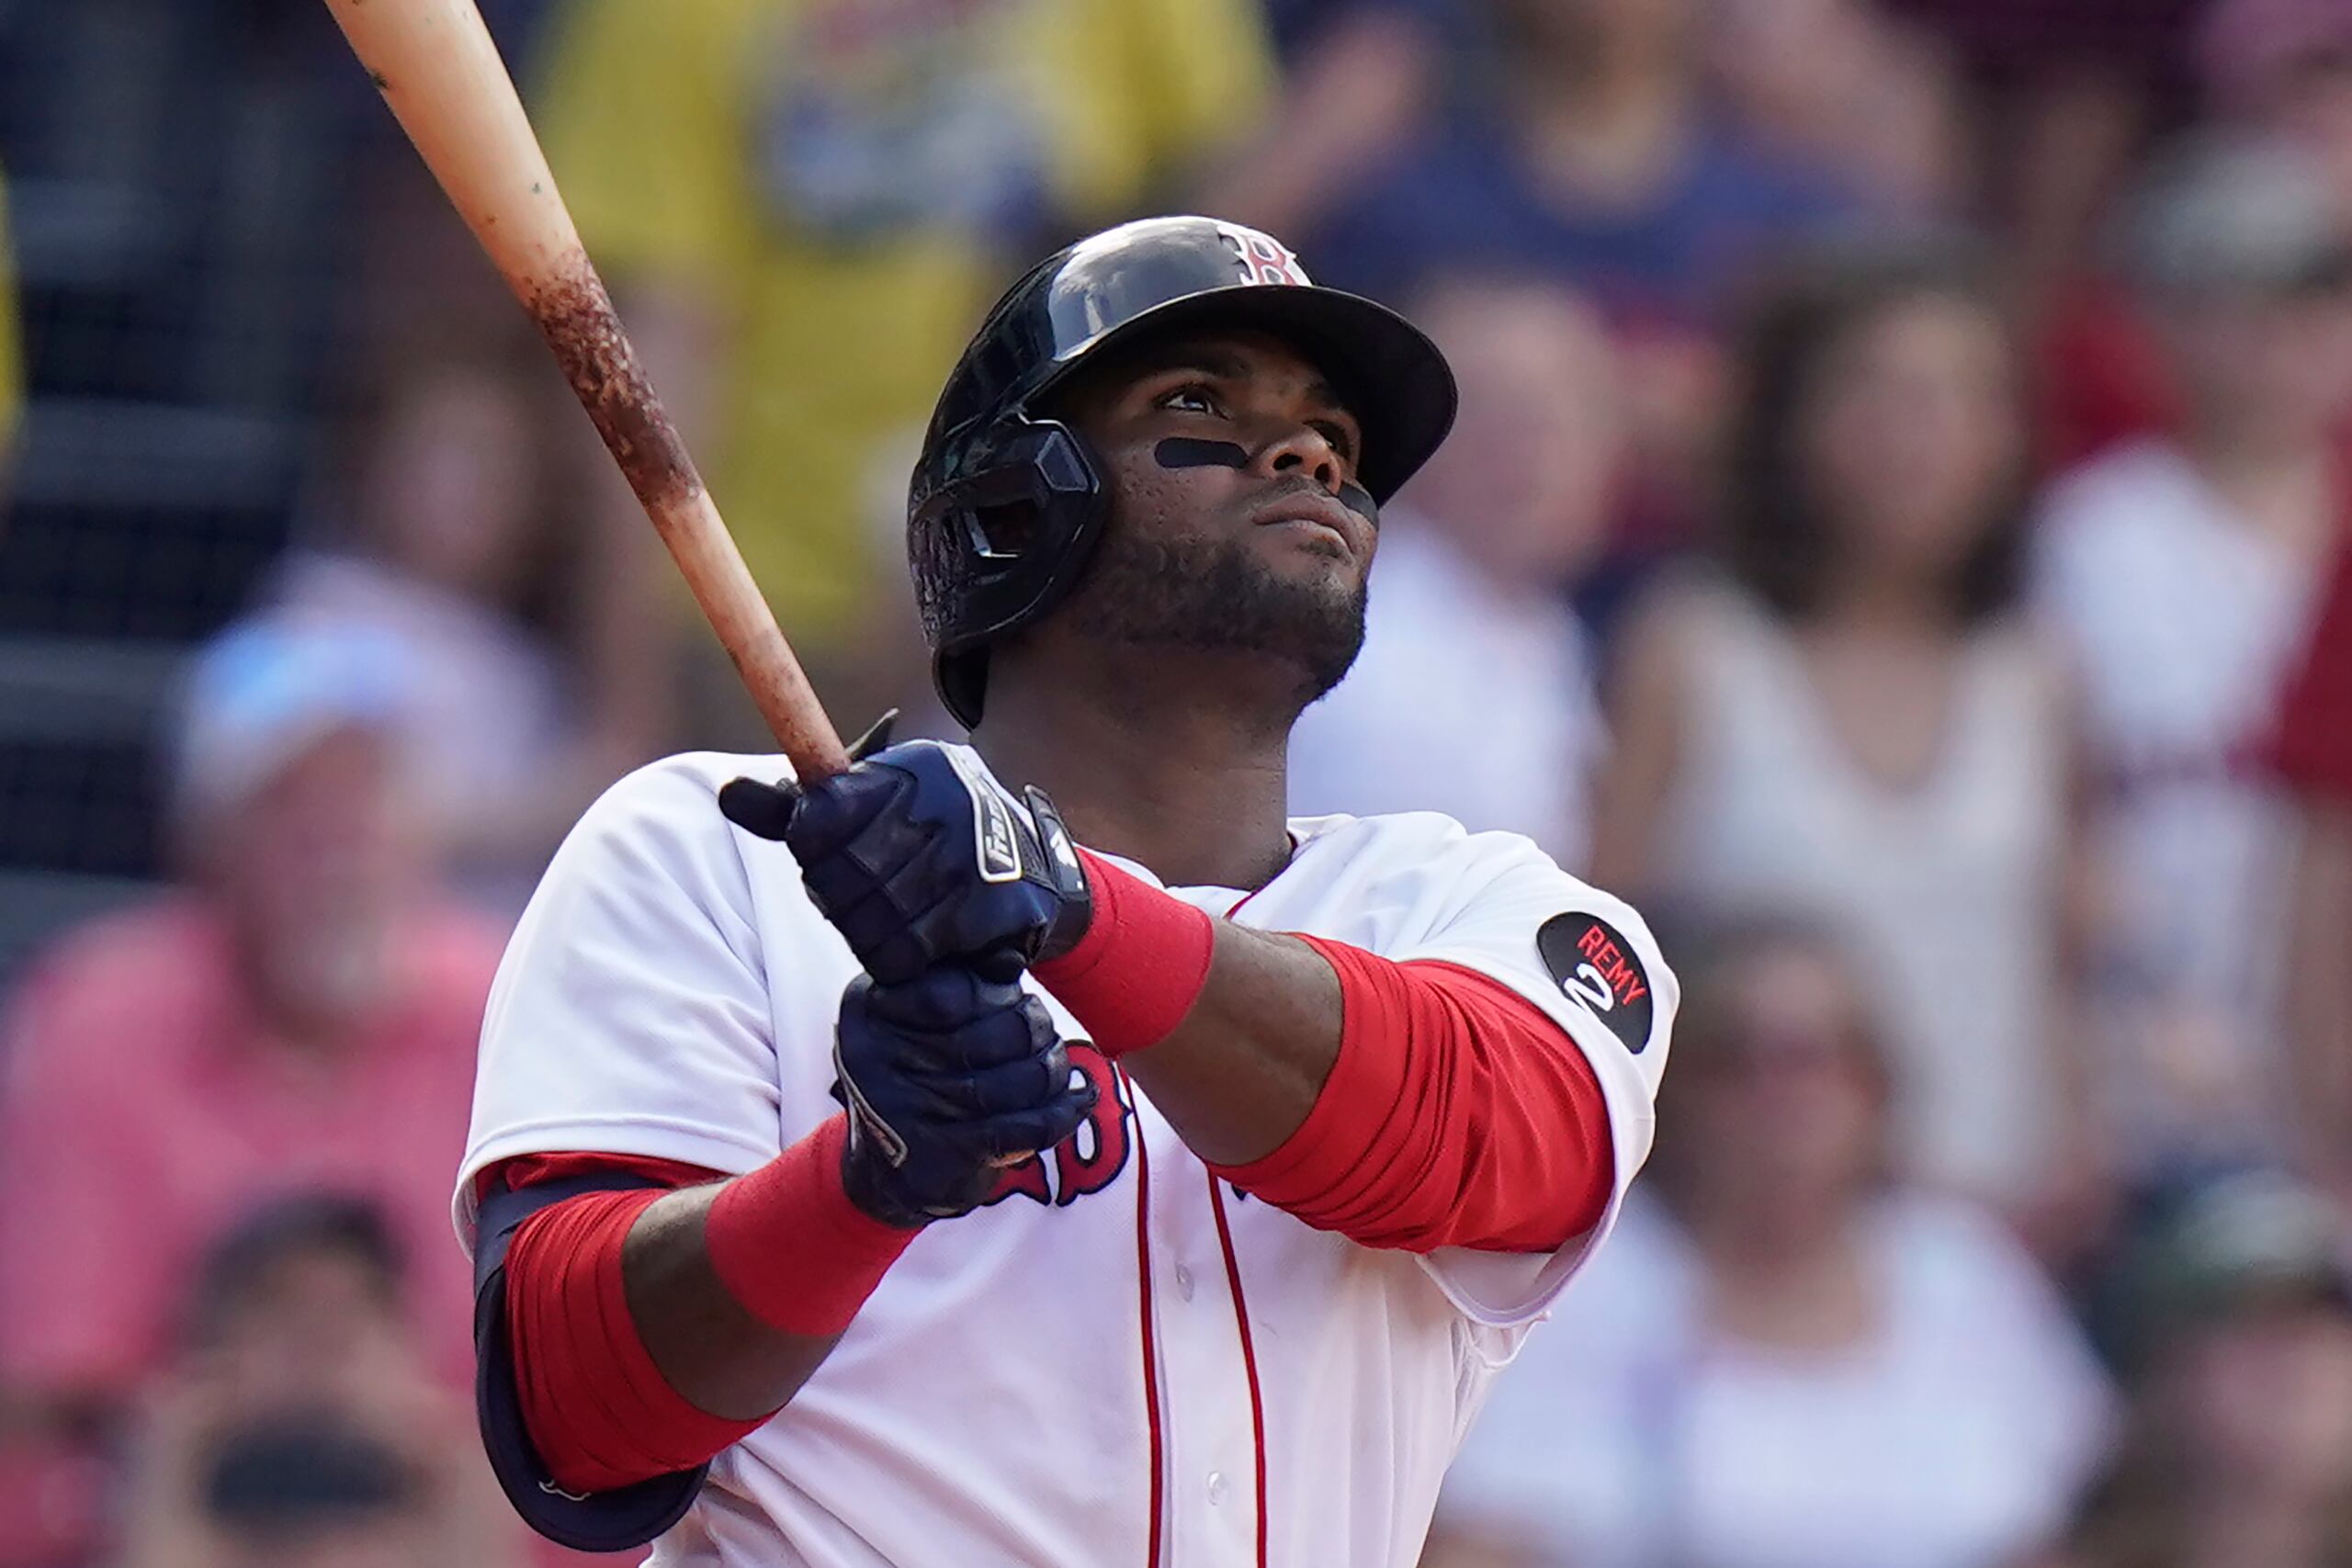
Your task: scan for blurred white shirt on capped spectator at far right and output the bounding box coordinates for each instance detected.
[2037,440,2317,1143]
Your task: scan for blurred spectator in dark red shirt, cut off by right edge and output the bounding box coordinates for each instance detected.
[2277,547,2352,1208]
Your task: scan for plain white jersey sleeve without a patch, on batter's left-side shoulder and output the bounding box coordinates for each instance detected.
[454,757,823,1239]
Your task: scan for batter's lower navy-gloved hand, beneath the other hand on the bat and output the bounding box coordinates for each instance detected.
[832,964,1099,1227]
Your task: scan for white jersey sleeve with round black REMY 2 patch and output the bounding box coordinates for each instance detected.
[1385,832,1681,1328]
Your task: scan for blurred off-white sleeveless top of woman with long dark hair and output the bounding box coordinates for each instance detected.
[1658,585,2067,1201]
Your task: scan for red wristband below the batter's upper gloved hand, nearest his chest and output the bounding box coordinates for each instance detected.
[1030,849,1216,1058]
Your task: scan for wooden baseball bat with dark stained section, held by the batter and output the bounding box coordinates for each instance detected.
[327,0,849,778]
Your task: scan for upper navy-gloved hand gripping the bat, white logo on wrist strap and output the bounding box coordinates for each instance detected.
[719,740,1093,985]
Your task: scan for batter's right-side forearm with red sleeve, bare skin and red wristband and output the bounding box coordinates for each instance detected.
[1037,856,1616,1251]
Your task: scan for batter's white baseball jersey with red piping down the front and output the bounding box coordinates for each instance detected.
[457,752,1677,1568]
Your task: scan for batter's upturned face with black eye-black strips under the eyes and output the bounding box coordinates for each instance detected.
[1063,332,1378,701]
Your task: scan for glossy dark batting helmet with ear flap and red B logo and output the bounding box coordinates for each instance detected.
[908,219,1453,727]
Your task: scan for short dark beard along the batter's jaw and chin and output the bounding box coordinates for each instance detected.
[1070,525,1364,712]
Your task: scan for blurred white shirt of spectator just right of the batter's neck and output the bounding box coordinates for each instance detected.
[1291,524,1606,865]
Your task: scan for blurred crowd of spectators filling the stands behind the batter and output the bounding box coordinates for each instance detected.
[0,0,2352,1568]
